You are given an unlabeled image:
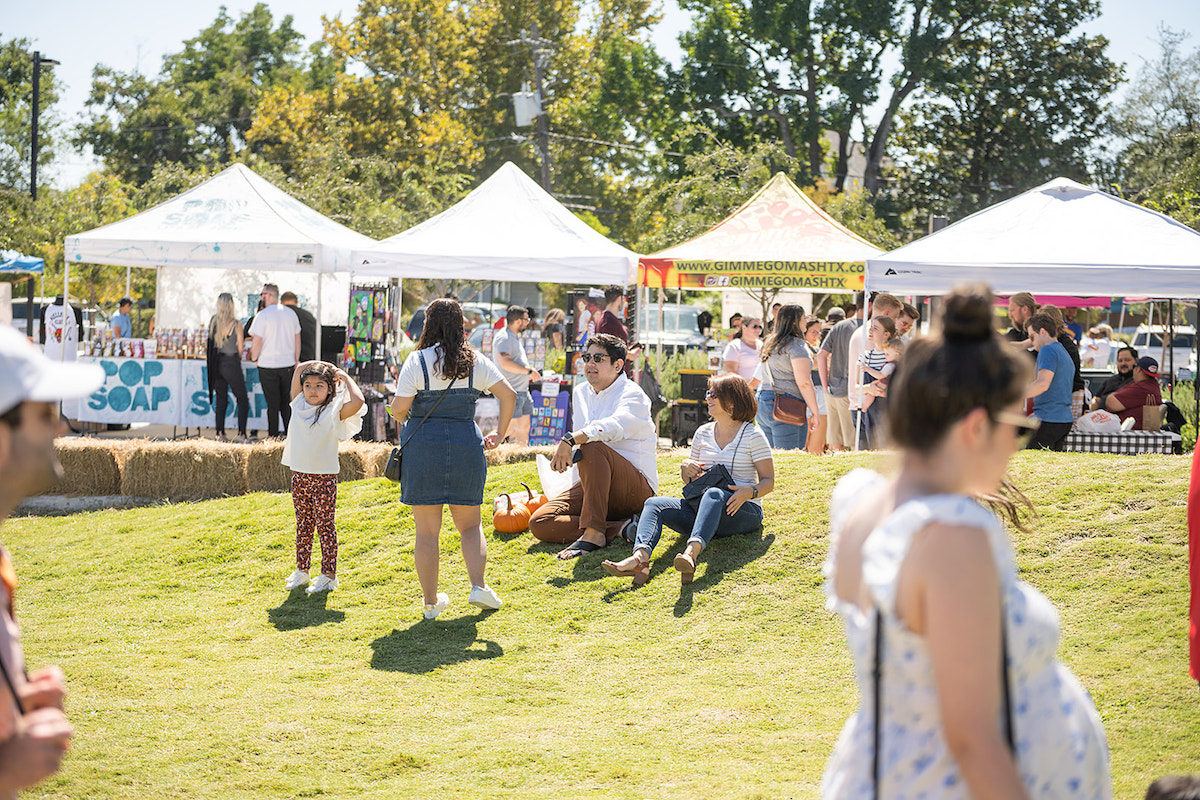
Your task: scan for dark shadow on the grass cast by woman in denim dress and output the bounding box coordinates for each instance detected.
[371,612,504,674]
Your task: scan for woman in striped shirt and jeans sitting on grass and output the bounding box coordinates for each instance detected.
[601,374,775,587]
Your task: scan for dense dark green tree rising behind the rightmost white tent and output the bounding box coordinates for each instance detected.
[894,0,1121,226]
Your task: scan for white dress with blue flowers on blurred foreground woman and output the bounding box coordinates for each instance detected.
[821,469,1112,800]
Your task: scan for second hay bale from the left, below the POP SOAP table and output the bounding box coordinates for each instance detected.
[121,439,246,500]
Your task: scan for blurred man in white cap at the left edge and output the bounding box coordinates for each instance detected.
[0,327,104,796]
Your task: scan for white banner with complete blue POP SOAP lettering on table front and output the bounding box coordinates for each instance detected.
[77,356,184,425]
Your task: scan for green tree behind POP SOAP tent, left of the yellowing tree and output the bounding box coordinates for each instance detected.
[74,4,304,182]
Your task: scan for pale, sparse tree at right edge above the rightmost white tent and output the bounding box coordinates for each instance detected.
[1103,28,1200,230]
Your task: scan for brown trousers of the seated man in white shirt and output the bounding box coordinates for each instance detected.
[529,441,654,545]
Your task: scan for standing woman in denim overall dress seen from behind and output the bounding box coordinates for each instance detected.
[391,299,516,619]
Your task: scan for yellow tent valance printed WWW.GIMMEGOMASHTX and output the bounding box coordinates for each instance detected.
[638,259,866,294]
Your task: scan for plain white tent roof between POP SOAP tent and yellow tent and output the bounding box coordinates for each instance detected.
[352,162,637,284]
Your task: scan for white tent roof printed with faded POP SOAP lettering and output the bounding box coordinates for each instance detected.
[66,164,374,272]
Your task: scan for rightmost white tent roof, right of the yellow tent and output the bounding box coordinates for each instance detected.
[866,178,1200,297]
